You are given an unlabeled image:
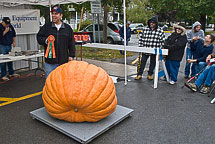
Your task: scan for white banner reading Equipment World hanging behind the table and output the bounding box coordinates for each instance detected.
[0,9,40,35]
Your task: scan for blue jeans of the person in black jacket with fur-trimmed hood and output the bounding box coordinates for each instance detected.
[165,59,180,82]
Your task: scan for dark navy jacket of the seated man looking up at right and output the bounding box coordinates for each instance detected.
[190,39,214,62]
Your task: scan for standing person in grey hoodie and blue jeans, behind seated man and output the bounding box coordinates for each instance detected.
[184,21,204,79]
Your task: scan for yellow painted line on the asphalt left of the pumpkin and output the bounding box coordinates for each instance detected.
[0,91,42,106]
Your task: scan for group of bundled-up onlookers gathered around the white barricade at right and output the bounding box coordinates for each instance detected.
[135,16,215,93]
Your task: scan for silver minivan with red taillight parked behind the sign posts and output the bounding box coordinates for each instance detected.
[82,23,121,44]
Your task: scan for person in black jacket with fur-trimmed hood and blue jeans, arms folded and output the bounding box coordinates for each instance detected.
[161,23,187,85]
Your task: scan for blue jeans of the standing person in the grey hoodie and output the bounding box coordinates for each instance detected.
[184,48,196,76]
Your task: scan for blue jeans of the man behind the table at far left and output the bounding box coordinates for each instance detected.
[0,45,14,77]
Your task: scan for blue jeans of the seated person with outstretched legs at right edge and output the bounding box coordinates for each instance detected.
[195,64,215,89]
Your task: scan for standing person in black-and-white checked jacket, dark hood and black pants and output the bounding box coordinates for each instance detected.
[135,16,165,80]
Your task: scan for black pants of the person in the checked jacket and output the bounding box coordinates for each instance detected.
[137,53,156,75]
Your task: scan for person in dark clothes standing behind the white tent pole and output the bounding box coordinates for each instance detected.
[119,21,131,55]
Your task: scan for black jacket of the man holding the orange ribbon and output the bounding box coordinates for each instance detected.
[37,22,75,64]
